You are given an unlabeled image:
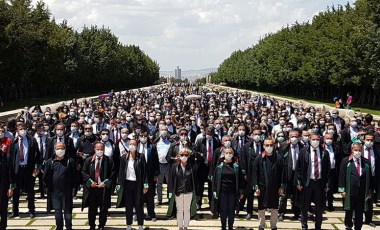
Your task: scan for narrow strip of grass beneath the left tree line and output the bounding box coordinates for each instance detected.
[0,92,99,112]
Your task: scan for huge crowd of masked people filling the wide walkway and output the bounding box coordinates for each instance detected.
[0,84,380,230]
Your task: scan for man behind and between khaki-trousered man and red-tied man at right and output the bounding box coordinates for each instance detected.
[278,129,303,221]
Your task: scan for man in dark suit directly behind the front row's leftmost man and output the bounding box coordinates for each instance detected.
[45,123,76,160]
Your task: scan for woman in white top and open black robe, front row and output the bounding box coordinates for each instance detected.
[116,140,149,230]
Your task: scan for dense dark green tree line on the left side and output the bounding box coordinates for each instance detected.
[0,0,159,100]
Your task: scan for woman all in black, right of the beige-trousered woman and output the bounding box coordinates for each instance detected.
[213,148,244,230]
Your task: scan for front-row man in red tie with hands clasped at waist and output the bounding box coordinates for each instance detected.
[82,142,114,230]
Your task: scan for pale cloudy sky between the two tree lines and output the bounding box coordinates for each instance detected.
[34,0,355,70]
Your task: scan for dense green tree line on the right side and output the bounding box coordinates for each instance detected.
[212,0,380,106]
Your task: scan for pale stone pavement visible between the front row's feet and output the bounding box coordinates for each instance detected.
[8,183,380,230]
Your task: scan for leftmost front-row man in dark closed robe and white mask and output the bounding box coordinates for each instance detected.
[43,142,76,230]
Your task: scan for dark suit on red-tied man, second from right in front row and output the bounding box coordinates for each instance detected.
[296,147,330,229]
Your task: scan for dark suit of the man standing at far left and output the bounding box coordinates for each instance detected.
[9,136,42,216]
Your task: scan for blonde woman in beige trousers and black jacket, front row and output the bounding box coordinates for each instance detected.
[167,148,197,230]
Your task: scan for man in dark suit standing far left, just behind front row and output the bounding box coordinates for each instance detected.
[9,124,42,218]
